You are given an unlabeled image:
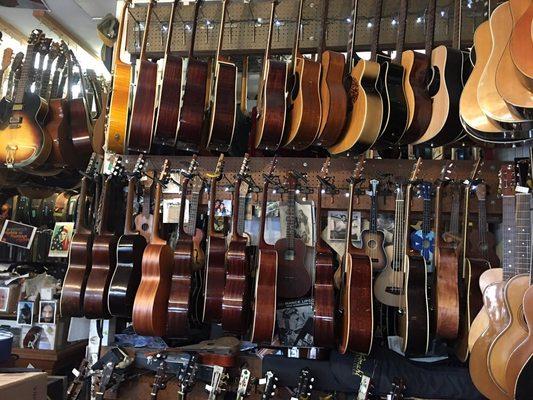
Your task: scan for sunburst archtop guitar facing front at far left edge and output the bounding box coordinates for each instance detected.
[0,30,52,168]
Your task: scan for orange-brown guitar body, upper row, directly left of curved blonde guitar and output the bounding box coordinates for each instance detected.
[315,51,348,147]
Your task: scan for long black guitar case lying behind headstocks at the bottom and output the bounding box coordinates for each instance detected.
[262,346,484,400]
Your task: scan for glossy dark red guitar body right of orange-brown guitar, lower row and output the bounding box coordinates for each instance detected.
[167,237,193,337]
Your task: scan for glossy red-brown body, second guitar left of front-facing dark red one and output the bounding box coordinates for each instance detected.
[222,237,250,334]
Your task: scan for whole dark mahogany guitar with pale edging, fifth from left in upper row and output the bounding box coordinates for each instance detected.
[207,0,237,152]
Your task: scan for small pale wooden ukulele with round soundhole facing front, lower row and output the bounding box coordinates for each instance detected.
[361,179,388,271]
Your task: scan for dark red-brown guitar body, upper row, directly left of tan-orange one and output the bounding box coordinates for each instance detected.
[255,60,287,150]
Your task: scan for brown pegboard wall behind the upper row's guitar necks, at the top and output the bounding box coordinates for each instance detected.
[126,0,486,57]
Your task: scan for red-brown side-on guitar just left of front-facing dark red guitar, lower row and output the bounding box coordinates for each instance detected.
[250,158,278,344]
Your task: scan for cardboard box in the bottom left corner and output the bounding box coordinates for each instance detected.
[0,372,47,400]
